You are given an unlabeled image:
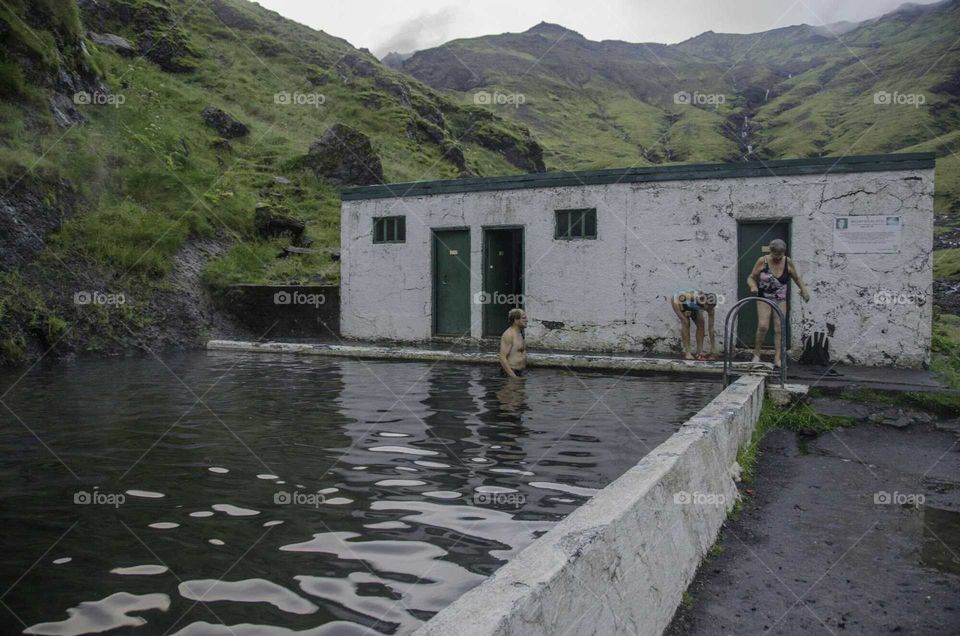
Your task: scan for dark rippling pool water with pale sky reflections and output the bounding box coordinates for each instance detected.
[0,353,719,636]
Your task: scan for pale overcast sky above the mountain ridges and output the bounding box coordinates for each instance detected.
[251,0,932,57]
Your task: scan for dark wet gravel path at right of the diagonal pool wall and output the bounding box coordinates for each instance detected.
[666,423,960,636]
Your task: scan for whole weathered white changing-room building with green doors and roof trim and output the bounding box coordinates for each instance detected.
[340,153,934,366]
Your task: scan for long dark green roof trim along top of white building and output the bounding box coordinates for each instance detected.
[340,152,936,201]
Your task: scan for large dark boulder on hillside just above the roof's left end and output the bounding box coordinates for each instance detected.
[304,124,383,185]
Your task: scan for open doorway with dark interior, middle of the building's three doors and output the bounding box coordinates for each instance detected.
[482,228,523,336]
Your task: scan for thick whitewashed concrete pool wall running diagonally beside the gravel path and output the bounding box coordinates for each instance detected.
[415,375,765,636]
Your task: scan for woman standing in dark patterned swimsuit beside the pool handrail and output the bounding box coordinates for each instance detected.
[747,239,810,369]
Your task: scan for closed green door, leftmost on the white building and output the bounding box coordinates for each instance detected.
[433,230,470,336]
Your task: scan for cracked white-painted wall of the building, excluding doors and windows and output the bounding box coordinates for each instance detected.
[341,170,933,366]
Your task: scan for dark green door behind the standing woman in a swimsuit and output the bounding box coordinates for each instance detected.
[740,221,790,348]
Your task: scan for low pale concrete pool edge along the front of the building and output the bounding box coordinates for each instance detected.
[207,340,773,375]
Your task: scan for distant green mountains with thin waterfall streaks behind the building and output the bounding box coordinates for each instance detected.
[393,0,960,215]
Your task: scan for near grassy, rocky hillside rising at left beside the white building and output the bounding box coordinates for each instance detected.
[0,0,543,363]
